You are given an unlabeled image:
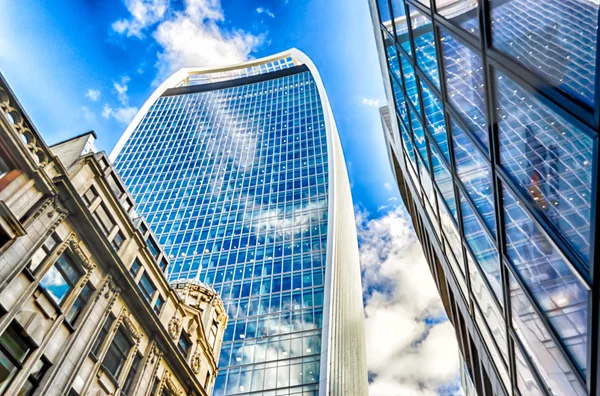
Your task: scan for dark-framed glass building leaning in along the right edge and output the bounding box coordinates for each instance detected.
[370,0,600,395]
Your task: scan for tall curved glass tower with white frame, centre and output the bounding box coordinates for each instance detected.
[111,49,367,395]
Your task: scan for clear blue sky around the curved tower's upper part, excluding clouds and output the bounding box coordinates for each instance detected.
[0,0,397,217]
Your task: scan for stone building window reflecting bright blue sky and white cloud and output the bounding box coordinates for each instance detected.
[40,254,81,305]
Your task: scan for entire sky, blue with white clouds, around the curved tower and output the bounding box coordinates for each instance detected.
[0,0,460,396]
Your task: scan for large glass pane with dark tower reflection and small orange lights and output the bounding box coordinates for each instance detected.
[496,73,593,260]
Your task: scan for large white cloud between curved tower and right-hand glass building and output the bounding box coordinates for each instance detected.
[357,206,459,396]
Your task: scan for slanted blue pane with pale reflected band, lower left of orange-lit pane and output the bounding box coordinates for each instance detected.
[451,122,496,236]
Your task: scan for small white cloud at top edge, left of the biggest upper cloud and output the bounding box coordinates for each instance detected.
[112,0,168,38]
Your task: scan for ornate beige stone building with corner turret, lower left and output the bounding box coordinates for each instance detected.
[0,72,227,396]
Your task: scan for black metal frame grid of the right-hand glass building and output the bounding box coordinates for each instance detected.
[376,0,600,395]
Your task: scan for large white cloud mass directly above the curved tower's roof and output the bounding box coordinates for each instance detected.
[113,0,264,81]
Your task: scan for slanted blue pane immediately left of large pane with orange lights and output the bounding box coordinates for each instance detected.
[440,30,489,149]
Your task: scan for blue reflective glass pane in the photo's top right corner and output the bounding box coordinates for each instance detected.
[490,0,600,105]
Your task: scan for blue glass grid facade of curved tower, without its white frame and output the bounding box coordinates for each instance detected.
[116,69,328,395]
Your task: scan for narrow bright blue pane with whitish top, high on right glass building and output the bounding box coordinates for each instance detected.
[408,6,440,89]
